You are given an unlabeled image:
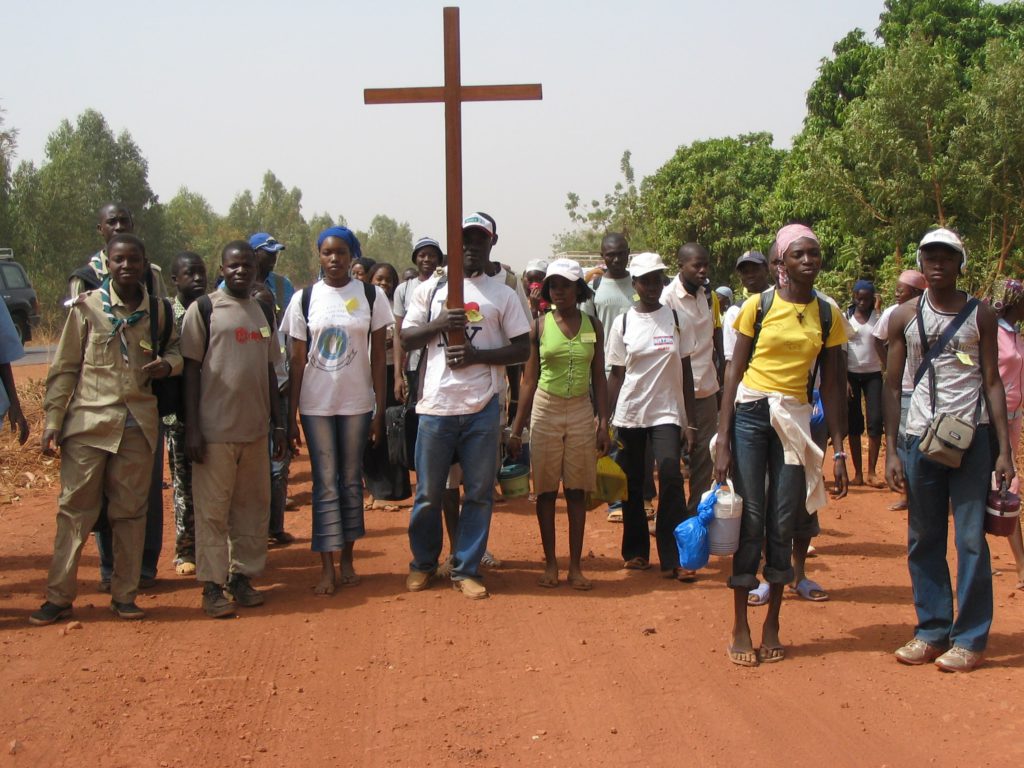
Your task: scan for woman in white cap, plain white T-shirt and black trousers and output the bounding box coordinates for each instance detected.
[606,253,695,581]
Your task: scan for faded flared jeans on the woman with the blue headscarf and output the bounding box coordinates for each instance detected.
[301,413,371,552]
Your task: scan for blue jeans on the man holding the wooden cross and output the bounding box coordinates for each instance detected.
[409,395,501,581]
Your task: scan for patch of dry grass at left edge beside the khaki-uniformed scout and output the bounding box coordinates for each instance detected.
[0,379,60,504]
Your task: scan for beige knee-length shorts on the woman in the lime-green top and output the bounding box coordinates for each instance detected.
[529,389,597,494]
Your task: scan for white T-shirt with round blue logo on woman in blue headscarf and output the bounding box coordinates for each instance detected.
[281,280,394,416]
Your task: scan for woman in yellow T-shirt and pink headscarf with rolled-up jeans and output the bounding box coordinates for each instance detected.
[715,224,848,667]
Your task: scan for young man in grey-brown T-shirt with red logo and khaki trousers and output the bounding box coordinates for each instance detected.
[181,241,286,617]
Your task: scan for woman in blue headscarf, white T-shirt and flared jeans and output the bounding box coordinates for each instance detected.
[282,226,394,595]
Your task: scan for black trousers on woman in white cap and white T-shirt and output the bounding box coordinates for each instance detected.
[616,424,686,571]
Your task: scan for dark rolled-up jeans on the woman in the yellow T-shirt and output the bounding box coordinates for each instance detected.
[729,398,807,590]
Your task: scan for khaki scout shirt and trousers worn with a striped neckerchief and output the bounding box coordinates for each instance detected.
[43,285,182,605]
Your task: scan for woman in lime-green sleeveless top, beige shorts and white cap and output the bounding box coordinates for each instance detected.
[509,259,608,590]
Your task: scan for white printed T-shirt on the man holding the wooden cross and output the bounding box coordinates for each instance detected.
[402,274,529,416]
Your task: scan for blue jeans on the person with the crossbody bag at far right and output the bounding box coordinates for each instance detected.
[900,424,992,651]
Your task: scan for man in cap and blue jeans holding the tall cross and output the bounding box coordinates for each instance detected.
[401,213,529,599]
